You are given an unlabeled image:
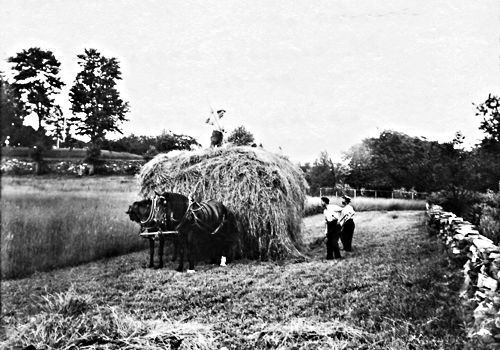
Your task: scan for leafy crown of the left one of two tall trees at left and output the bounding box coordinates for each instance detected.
[7,47,65,135]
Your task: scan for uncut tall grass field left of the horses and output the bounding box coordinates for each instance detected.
[1,177,145,278]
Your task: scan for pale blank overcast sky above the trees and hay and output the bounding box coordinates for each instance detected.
[0,0,500,163]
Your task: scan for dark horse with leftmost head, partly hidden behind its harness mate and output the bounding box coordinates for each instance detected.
[126,193,187,268]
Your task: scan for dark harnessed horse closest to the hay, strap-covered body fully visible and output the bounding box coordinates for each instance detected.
[158,194,229,272]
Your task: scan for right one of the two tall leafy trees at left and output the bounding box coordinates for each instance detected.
[69,49,129,162]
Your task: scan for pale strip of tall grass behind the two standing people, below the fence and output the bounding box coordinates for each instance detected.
[305,196,426,216]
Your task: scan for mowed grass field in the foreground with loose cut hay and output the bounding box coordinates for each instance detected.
[0,211,474,349]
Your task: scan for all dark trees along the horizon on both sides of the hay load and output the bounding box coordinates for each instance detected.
[0,48,500,213]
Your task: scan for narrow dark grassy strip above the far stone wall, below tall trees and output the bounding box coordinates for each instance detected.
[2,147,143,160]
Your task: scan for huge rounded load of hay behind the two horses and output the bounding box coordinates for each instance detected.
[138,146,307,260]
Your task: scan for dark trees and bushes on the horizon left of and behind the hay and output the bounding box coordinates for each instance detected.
[0,47,262,172]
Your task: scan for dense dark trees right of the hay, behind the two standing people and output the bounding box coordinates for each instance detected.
[301,94,500,213]
